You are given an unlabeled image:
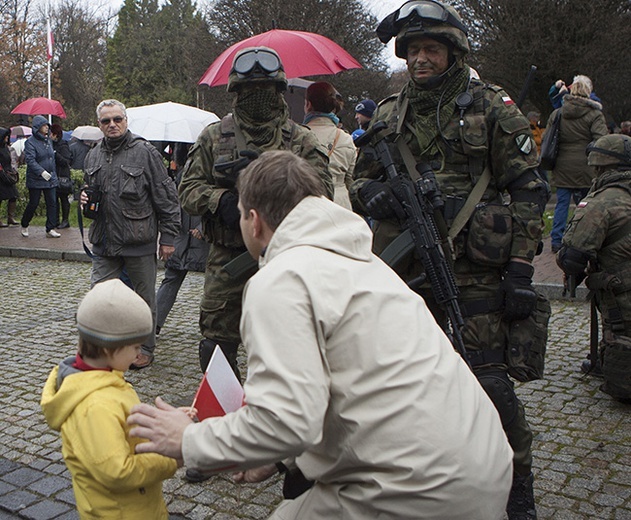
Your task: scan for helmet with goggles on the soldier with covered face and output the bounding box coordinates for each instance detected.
[228,47,287,92]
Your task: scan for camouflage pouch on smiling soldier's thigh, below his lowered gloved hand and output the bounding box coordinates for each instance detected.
[506,292,552,383]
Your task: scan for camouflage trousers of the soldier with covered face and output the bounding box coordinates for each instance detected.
[199,244,249,344]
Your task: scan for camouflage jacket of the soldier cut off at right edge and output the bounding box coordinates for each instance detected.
[563,170,631,272]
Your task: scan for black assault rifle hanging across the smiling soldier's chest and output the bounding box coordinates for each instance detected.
[355,121,471,366]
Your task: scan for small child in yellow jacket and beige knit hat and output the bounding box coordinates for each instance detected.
[41,279,177,520]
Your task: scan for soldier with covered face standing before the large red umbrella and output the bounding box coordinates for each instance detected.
[179,47,333,382]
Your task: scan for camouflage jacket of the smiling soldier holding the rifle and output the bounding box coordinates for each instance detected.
[351,79,548,284]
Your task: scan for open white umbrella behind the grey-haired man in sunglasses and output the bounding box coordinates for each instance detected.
[127,101,219,143]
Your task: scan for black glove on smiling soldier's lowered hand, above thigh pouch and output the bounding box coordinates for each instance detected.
[502,262,537,321]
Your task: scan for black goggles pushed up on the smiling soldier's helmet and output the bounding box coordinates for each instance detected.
[377,0,467,43]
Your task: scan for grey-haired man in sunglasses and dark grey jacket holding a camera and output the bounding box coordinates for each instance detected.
[81,99,180,369]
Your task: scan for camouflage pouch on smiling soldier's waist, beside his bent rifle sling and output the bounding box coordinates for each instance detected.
[465,204,513,267]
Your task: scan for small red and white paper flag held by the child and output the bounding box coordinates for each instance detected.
[192,345,245,421]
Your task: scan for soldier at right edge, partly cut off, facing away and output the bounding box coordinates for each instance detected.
[557,134,631,403]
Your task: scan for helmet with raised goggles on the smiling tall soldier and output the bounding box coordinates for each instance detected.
[377,0,469,59]
